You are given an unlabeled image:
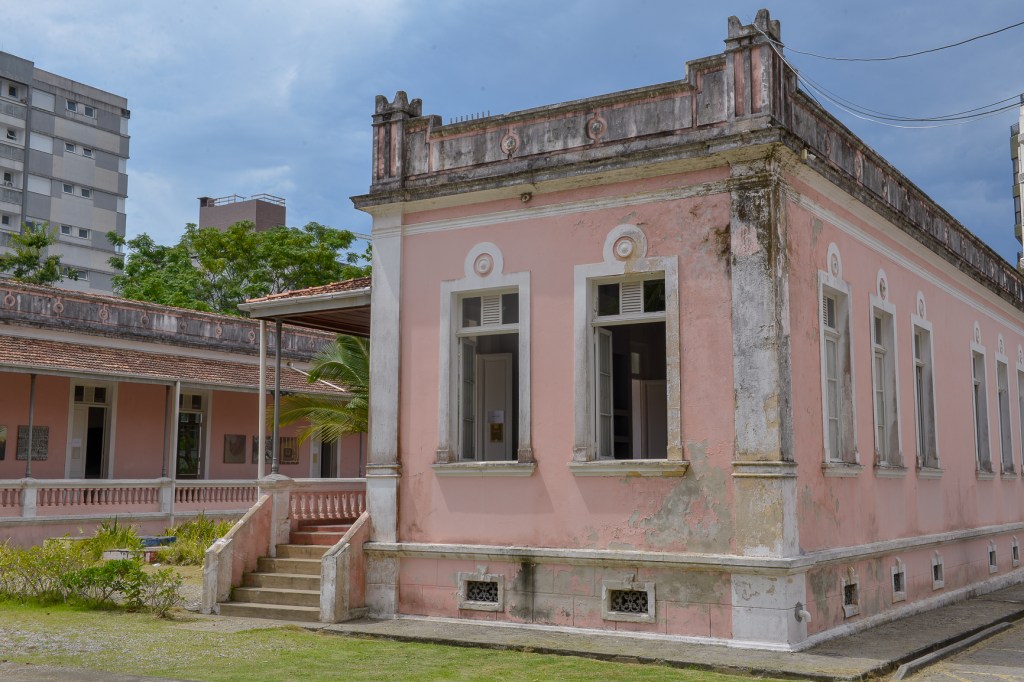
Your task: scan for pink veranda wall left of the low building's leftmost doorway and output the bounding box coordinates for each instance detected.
[0,372,71,478]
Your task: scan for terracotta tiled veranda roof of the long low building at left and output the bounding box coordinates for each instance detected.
[0,335,337,394]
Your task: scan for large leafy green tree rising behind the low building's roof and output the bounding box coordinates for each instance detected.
[109,221,370,315]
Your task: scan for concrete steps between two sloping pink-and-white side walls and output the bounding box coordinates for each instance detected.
[218,520,349,623]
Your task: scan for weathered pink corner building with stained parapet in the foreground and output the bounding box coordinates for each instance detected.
[299,11,1024,649]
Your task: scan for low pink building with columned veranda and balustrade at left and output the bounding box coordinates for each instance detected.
[0,281,365,543]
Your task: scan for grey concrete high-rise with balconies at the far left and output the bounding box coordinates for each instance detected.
[0,47,131,293]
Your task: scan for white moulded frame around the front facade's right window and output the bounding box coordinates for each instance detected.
[571,224,688,475]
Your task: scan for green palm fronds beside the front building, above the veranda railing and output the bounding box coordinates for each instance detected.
[279,336,370,441]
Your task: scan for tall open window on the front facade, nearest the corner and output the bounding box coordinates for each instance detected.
[593,274,668,460]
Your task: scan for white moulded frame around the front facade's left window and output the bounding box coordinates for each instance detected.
[434,242,534,475]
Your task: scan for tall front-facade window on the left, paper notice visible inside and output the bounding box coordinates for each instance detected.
[456,291,519,461]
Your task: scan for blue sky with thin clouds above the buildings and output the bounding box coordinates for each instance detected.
[0,0,1024,259]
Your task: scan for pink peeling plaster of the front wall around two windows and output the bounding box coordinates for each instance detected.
[398,169,734,552]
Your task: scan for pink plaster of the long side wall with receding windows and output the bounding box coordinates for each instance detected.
[787,179,1024,561]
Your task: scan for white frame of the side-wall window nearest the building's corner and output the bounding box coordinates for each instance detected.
[817,245,861,466]
